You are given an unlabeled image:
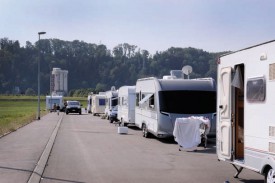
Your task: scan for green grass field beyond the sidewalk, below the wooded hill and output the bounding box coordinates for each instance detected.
[0,96,87,136]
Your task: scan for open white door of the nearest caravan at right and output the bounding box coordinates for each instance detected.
[217,67,232,160]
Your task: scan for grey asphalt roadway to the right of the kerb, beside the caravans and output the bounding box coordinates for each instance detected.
[41,114,263,183]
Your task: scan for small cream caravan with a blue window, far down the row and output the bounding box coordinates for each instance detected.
[91,93,106,116]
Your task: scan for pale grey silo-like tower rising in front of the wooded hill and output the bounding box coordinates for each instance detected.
[50,68,68,96]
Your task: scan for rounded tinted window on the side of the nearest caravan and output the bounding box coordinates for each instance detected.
[246,77,266,102]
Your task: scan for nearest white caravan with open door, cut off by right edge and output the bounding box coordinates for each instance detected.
[217,40,275,182]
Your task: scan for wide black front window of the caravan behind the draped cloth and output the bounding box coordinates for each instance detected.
[159,91,216,114]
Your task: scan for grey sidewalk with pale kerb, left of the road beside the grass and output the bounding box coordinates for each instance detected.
[0,113,62,183]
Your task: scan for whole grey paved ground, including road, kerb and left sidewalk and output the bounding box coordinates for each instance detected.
[0,113,263,183]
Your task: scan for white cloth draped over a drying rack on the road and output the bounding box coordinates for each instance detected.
[173,116,210,149]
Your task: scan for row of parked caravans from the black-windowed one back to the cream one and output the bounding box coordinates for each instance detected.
[87,73,216,138]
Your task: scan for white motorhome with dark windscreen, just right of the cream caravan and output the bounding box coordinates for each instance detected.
[104,87,118,120]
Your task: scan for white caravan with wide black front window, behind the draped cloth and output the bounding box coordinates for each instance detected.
[135,77,216,138]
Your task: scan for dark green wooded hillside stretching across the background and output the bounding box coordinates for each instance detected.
[0,38,229,96]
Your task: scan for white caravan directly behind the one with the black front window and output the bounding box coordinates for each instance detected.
[117,86,136,126]
